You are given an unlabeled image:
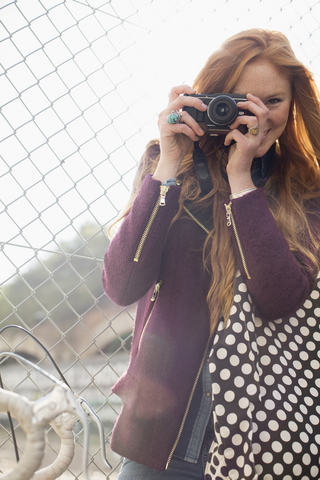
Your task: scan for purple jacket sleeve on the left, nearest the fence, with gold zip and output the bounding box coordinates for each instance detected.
[102,175,181,305]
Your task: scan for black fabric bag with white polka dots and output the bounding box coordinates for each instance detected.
[205,273,320,480]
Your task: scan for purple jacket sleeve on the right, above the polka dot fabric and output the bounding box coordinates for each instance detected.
[230,188,320,320]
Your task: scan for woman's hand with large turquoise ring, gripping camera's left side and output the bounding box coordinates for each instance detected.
[153,85,207,182]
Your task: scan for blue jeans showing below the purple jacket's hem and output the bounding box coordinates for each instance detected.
[118,434,214,480]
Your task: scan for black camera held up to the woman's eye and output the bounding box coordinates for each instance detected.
[183,93,253,136]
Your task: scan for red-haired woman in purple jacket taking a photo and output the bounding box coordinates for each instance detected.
[103,29,320,480]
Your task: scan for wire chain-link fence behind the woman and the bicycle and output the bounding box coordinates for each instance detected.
[0,0,320,480]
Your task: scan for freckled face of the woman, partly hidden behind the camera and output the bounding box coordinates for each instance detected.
[233,59,292,157]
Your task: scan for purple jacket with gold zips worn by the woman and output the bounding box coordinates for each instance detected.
[103,175,320,470]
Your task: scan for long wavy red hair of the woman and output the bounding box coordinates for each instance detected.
[111,29,320,331]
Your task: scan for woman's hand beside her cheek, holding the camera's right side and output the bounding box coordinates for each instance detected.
[224,93,269,193]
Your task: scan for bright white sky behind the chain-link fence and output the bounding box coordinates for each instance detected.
[0,0,320,284]
